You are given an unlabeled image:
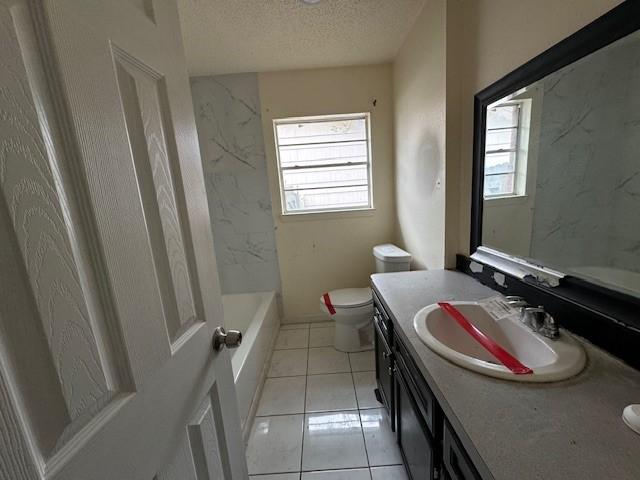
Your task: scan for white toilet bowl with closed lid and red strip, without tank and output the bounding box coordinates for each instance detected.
[320,287,373,352]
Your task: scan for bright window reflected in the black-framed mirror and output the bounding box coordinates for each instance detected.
[484,103,520,198]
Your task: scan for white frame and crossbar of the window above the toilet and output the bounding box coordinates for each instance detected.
[273,112,374,216]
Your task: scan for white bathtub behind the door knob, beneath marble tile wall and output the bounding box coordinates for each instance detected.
[222,292,280,438]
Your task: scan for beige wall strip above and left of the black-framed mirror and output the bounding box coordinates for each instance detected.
[452,0,621,260]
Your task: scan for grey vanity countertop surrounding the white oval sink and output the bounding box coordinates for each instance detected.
[371,270,640,480]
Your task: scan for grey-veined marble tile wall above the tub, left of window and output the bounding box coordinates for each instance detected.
[191,73,280,293]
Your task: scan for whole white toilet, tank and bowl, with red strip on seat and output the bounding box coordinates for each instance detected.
[320,243,411,352]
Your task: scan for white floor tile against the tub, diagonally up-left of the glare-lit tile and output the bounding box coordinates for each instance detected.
[256,376,307,417]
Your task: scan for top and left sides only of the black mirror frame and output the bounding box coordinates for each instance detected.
[469,0,640,254]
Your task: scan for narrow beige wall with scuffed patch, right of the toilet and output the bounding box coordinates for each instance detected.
[393,0,446,268]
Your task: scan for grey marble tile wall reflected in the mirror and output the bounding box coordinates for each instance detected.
[531,42,640,272]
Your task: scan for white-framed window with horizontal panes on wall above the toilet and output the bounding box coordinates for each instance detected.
[274,113,373,215]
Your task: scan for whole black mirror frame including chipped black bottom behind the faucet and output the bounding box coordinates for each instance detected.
[456,0,640,370]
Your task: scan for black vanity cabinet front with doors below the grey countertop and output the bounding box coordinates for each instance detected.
[373,292,481,480]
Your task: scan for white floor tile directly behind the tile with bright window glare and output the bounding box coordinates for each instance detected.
[305,373,358,412]
